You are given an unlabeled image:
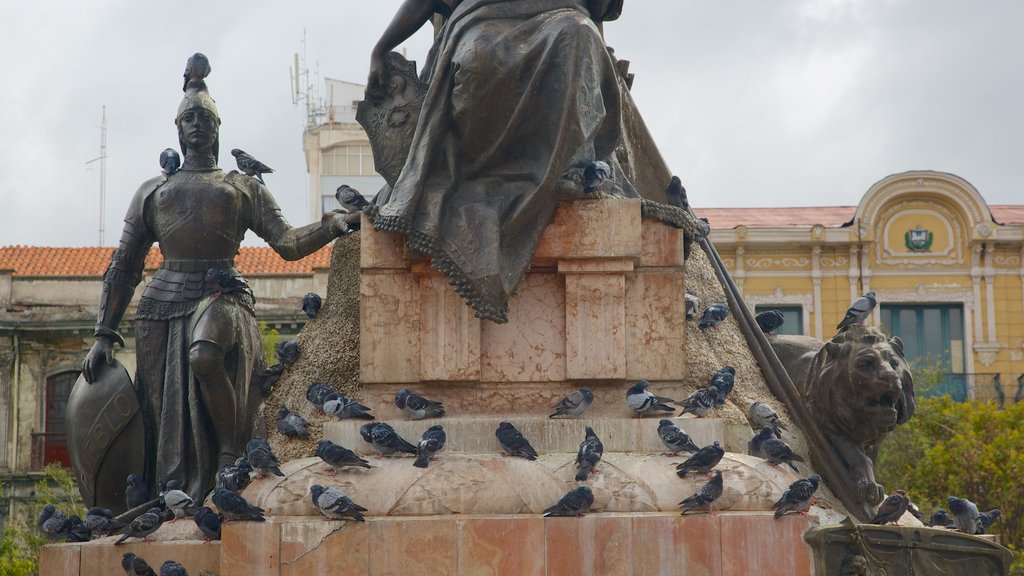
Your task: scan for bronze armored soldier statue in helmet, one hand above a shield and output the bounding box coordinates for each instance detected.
[70,55,347,502]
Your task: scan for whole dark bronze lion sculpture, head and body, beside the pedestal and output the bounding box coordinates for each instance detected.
[770,325,914,505]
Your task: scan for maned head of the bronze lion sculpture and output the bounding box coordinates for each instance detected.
[804,326,914,446]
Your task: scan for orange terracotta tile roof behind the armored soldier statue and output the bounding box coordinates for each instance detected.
[0,246,331,277]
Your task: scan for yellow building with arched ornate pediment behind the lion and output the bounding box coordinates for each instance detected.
[696,171,1024,403]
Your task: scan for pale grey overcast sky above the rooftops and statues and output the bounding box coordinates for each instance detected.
[0,0,1024,246]
